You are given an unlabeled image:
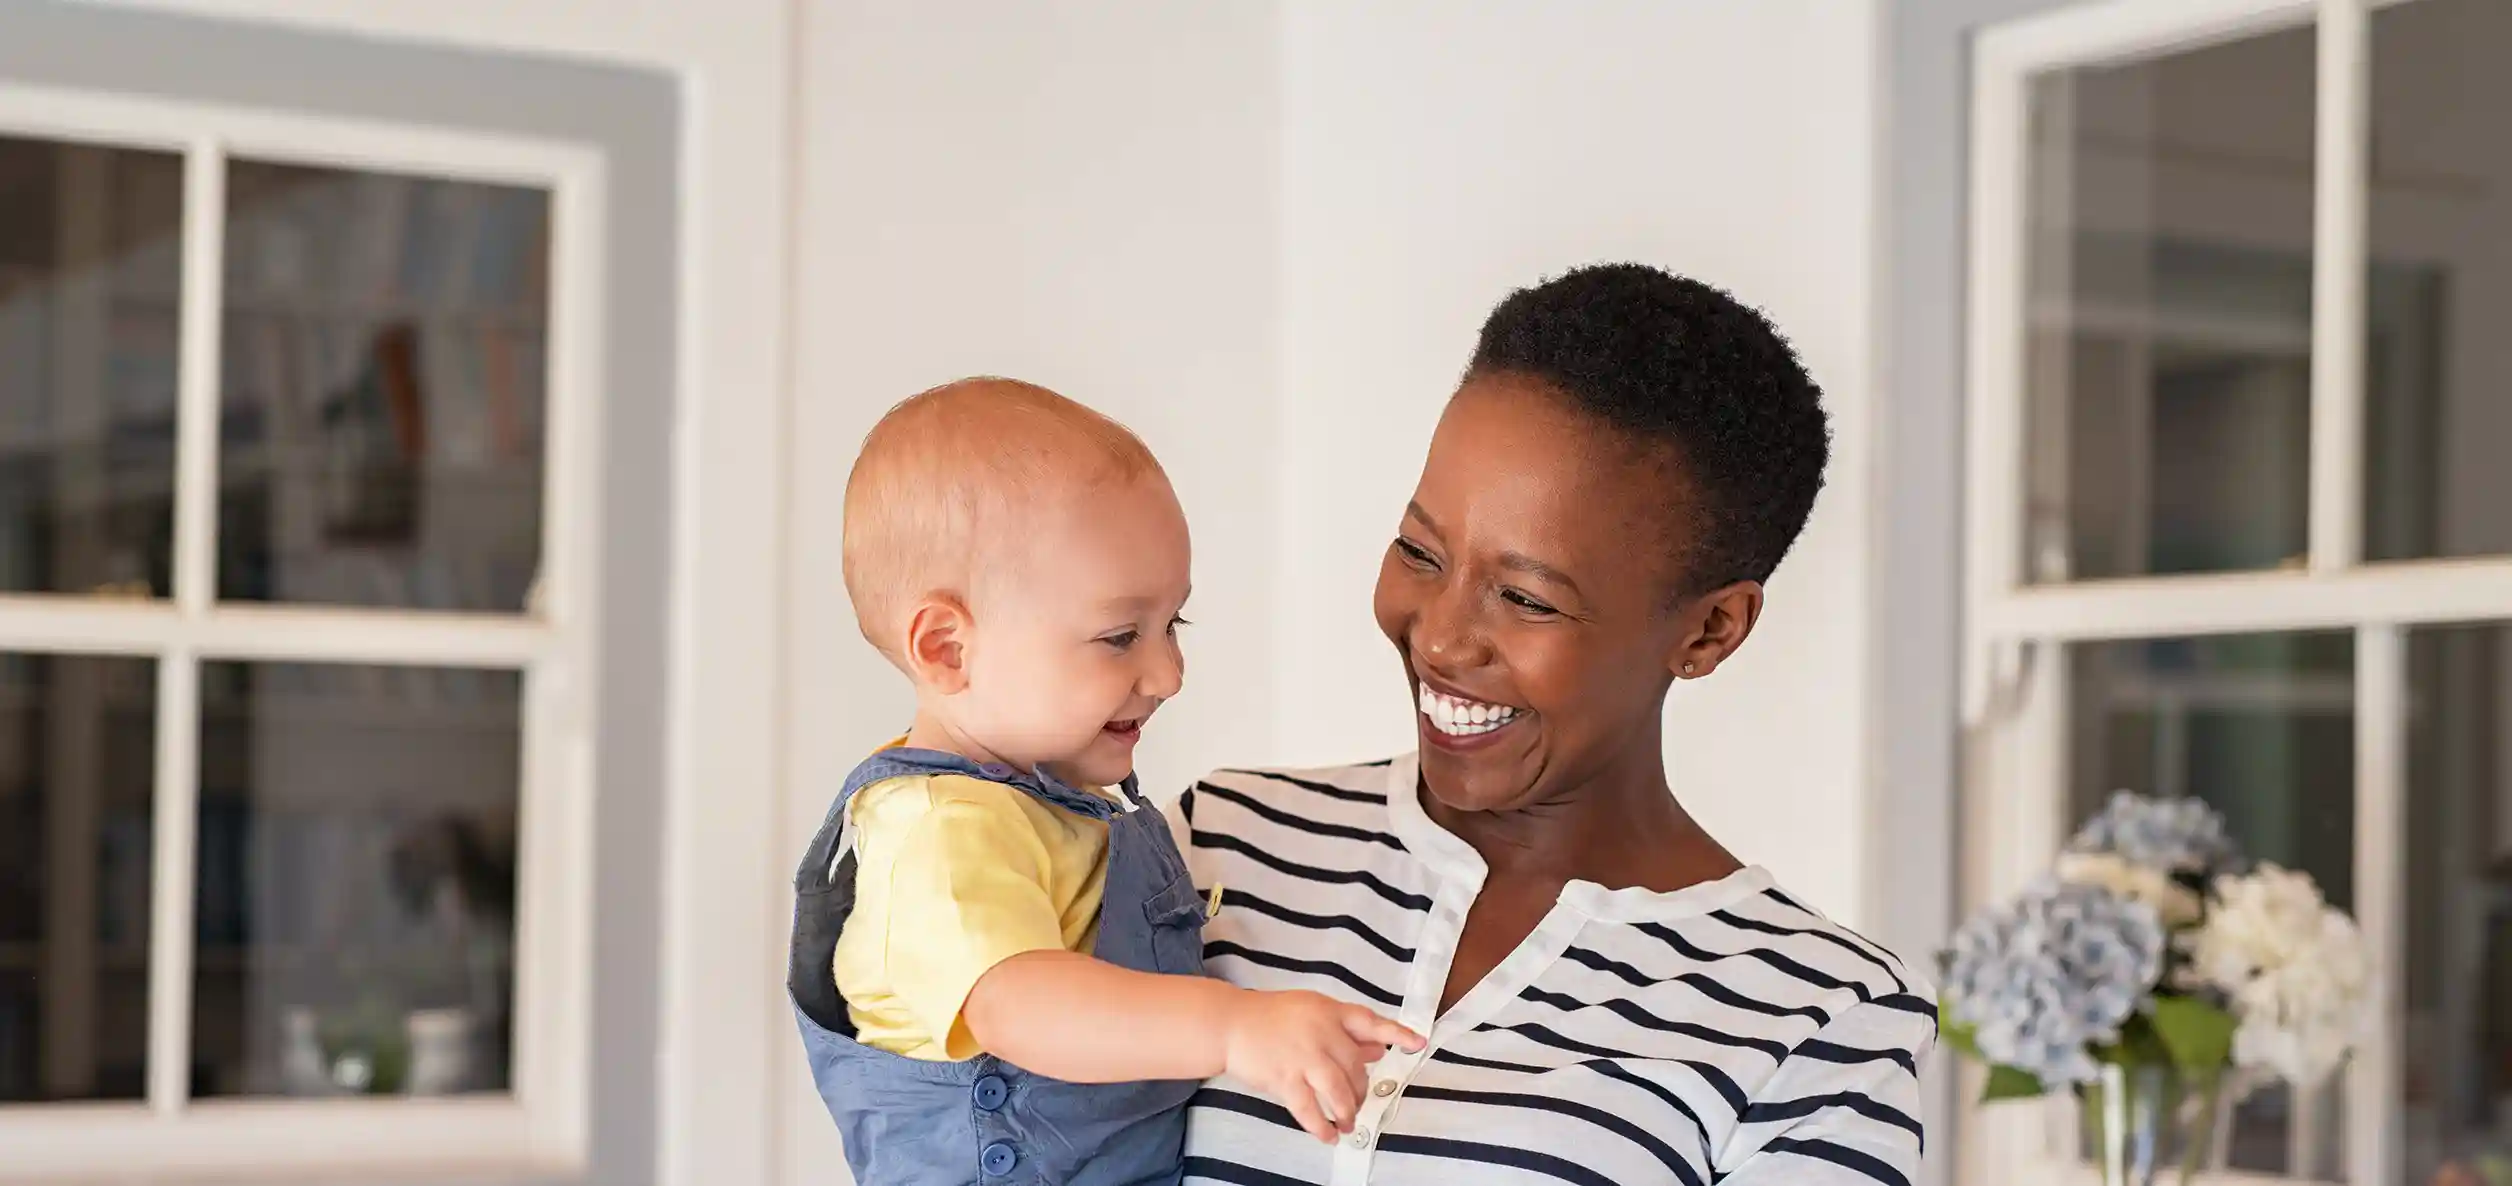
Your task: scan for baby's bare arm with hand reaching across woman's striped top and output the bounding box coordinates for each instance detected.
[960,952,1422,1141]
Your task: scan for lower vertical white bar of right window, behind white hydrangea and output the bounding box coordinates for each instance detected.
[2344,626,2409,1183]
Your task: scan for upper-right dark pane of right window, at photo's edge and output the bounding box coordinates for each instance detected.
[2364,0,2512,560]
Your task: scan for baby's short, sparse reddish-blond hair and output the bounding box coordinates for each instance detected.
[844,377,1168,663]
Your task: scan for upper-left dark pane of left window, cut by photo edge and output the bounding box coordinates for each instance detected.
[0,136,183,596]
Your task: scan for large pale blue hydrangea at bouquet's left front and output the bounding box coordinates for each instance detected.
[1944,877,2163,1088]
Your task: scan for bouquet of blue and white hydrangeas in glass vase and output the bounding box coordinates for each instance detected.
[1939,792,2369,1186]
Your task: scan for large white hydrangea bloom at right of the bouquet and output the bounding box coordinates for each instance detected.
[2180,864,2371,1085]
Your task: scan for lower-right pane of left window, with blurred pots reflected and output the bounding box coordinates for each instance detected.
[193,663,522,1096]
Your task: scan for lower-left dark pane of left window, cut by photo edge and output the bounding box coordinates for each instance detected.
[0,653,156,1101]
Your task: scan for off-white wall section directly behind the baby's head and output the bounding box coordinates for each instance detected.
[781,0,1279,1186]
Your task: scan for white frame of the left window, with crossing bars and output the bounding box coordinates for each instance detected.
[0,83,608,1181]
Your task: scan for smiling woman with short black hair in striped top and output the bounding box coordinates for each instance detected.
[1171,264,1937,1186]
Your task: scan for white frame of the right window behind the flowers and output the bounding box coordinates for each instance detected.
[1962,0,2512,1186]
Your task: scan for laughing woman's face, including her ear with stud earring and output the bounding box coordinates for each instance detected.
[1377,374,1761,812]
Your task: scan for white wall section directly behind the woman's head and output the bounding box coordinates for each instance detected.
[1274,0,1874,925]
